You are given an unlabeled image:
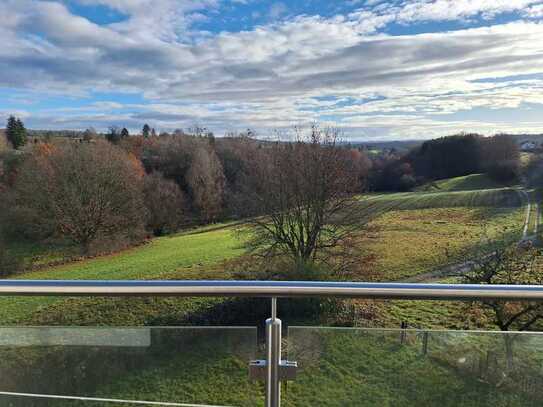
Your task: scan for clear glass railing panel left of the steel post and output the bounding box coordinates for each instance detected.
[0,327,263,407]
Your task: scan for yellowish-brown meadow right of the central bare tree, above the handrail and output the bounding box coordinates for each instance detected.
[361,207,525,281]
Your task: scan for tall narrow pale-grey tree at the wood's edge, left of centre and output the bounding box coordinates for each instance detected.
[187,145,225,222]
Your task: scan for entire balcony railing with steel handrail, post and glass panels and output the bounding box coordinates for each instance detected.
[0,280,543,406]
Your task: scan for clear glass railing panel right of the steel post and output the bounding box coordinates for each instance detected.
[283,327,543,407]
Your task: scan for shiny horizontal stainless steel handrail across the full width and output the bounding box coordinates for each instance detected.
[0,280,543,301]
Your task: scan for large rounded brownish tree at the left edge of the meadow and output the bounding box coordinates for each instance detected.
[15,142,145,254]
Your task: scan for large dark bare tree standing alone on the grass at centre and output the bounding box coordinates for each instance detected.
[247,126,366,266]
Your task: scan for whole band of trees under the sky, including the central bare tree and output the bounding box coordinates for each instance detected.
[0,118,528,278]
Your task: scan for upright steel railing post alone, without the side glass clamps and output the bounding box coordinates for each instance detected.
[266,297,281,407]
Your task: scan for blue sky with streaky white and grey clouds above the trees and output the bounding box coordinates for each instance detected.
[0,0,543,140]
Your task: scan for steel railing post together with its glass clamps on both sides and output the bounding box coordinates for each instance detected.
[249,297,298,407]
